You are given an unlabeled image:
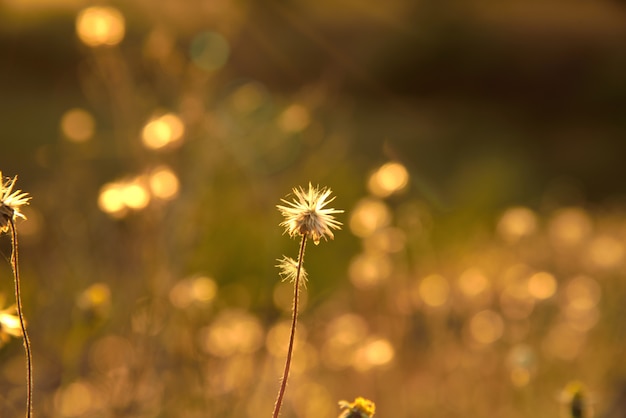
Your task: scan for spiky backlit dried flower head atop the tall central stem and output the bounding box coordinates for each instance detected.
[276,183,343,245]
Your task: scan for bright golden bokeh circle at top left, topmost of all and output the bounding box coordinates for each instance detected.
[76,6,126,47]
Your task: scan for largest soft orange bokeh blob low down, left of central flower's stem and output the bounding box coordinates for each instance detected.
[200,309,265,357]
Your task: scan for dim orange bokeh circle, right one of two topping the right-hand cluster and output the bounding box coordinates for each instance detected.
[548,207,593,247]
